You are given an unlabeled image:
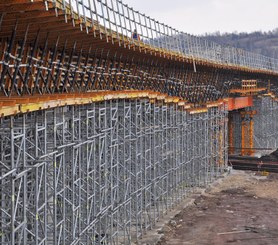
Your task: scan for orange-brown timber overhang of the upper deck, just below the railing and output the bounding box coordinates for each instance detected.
[0,0,277,75]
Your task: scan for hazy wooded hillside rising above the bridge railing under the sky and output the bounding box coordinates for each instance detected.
[203,28,278,58]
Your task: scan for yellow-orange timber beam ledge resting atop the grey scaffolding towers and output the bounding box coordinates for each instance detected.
[0,90,228,117]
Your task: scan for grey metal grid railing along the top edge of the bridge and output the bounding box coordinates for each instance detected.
[50,0,278,72]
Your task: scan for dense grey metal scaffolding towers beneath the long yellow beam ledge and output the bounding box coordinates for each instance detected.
[0,99,227,244]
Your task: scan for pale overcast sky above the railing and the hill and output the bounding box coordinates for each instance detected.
[122,0,278,34]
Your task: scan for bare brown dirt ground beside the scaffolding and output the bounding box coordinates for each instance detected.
[158,170,278,245]
